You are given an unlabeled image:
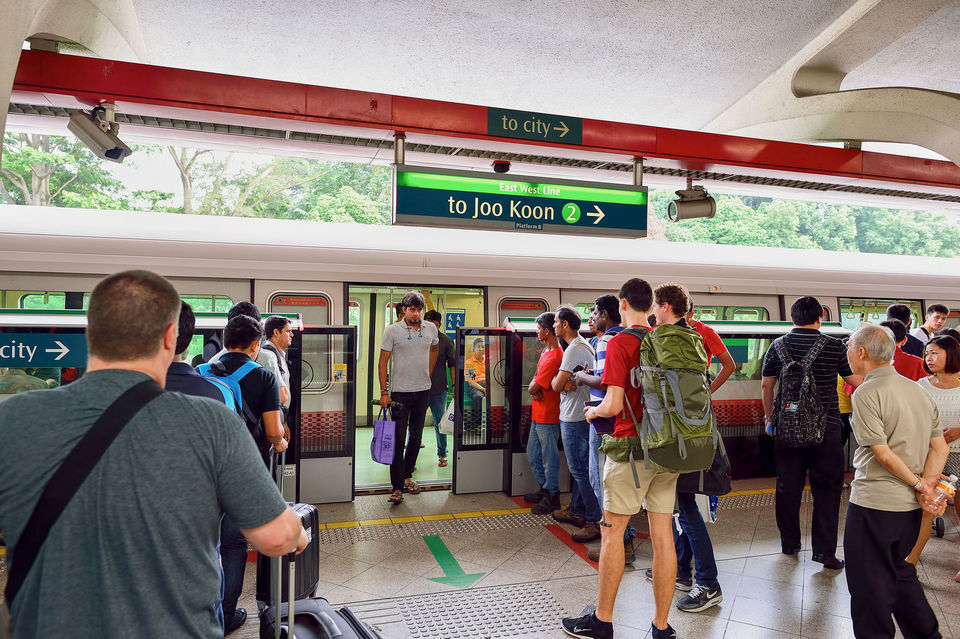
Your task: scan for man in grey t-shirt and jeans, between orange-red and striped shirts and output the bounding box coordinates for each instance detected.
[551,306,603,543]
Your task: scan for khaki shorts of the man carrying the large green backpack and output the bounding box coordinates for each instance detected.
[603,457,679,515]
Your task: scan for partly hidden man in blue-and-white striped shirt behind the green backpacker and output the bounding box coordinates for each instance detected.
[574,295,637,564]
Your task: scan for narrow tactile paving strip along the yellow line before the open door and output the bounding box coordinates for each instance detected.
[319,513,553,544]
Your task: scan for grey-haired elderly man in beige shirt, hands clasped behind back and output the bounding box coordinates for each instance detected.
[843,326,947,639]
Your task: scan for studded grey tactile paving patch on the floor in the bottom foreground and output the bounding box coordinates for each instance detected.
[350,582,566,639]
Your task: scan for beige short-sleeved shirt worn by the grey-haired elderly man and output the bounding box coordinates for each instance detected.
[850,366,943,512]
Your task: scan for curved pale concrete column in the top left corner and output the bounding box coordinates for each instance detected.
[0,0,147,168]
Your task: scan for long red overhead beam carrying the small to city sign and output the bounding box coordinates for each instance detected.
[13,51,960,188]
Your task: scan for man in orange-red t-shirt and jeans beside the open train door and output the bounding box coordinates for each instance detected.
[523,313,563,515]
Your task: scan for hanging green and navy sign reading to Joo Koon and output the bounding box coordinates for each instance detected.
[393,166,647,237]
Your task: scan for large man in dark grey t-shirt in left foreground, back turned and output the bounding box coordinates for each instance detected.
[0,271,307,639]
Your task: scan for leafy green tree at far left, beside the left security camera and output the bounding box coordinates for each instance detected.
[0,133,129,209]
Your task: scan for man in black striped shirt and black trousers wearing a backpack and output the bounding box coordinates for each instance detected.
[761,296,861,570]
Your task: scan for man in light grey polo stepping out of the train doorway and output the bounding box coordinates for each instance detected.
[377,291,440,504]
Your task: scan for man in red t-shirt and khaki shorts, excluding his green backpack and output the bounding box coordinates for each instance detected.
[561,278,677,639]
